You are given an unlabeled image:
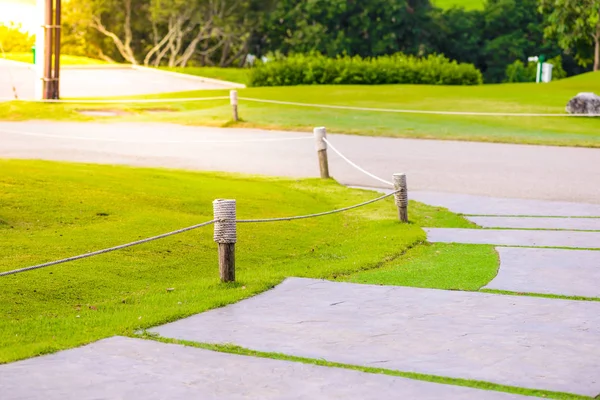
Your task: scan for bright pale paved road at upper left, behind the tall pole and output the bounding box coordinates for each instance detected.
[0,59,234,99]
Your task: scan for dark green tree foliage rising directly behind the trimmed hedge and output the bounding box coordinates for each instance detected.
[259,0,434,57]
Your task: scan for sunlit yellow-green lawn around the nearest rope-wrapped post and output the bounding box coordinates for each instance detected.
[0,160,488,363]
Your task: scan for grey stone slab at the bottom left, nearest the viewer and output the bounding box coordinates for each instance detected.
[0,337,526,400]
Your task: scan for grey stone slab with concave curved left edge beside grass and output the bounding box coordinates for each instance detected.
[486,247,600,298]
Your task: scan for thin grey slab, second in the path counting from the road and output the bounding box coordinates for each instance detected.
[466,217,600,231]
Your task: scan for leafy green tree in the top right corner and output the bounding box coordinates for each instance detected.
[539,0,600,71]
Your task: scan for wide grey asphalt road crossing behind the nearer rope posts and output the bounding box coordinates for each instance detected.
[0,122,600,204]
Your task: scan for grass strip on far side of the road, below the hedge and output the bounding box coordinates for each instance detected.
[0,73,600,147]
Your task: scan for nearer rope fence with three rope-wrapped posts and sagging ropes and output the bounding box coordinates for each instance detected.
[0,135,408,282]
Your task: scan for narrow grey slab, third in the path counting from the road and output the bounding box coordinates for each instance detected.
[424,228,600,249]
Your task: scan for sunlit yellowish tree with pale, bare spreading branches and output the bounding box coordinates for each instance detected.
[65,0,272,67]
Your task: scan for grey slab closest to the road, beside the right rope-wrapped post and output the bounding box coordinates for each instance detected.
[408,191,600,217]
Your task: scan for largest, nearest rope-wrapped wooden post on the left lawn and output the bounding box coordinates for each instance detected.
[213,199,237,282]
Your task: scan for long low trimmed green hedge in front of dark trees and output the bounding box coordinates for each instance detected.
[250,53,483,86]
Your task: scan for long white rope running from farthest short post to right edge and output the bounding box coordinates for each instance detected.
[239,97,600,117]
